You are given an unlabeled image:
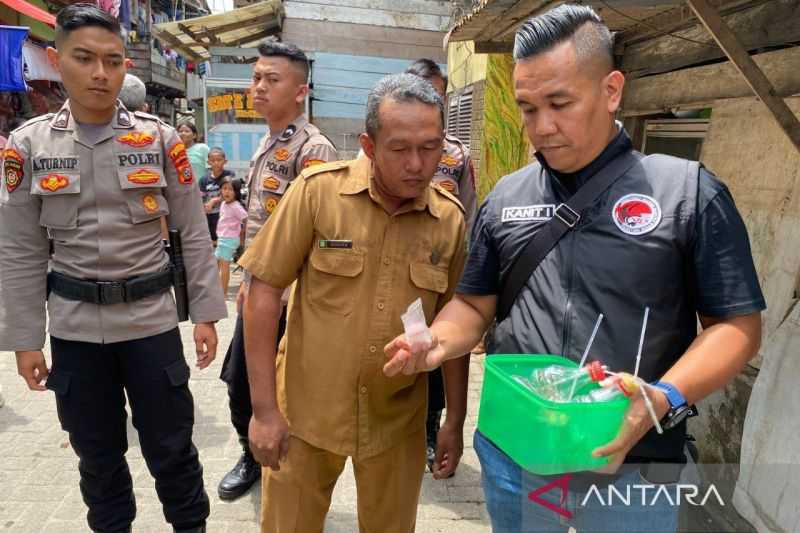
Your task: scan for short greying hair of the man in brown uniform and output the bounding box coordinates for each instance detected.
[366,73,444,139]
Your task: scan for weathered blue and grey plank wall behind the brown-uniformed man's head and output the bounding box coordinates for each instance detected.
[282,0,450,158]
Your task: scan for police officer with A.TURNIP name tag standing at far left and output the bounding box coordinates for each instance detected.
[0,4,226,532]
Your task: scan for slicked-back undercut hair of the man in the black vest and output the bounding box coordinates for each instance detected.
[514,4,614,72]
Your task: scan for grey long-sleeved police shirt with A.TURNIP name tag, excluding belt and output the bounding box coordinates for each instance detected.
[0,102,226,351]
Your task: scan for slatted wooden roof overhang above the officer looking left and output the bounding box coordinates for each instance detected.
[153,0,284,61]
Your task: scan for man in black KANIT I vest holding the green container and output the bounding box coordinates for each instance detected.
[384,5,765,532]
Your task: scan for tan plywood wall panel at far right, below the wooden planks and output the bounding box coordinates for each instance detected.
[702,97,800,354]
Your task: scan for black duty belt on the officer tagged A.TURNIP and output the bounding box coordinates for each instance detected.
[47,270,172,305]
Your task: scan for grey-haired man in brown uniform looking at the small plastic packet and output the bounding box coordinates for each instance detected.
[240,74,467,533]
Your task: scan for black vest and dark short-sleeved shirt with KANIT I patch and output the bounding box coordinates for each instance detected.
[456,130,765,458]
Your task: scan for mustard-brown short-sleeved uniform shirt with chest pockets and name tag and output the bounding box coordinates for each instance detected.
[240,158,465,457]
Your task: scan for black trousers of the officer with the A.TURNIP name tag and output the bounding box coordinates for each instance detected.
[47,328,209,532]
